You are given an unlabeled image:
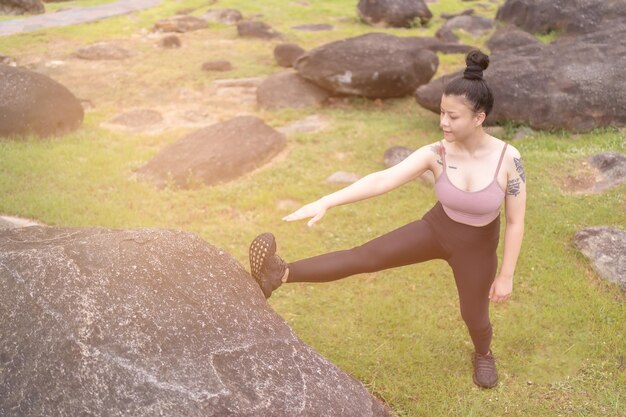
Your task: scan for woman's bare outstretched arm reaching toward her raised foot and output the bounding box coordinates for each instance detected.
[283,145,434,226]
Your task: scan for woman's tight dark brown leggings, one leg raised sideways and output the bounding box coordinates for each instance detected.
[288,203,500,353]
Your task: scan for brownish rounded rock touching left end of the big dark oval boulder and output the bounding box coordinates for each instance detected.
[257,71,330,109]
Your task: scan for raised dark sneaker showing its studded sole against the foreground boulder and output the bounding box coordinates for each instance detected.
[248,233,287,298]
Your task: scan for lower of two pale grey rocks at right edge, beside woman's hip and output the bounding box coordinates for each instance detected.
[574,226,626,292]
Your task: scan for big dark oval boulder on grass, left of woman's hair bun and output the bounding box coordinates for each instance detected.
[294,33,439,98]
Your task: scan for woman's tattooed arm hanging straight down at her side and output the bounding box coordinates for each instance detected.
[489,147,526,303]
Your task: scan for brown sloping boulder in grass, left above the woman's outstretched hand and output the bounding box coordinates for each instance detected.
[138,116,285,188]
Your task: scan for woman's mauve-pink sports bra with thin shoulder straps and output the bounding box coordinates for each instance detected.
[435,142,508,226]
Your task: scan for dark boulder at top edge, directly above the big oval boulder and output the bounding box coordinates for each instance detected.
[357,0,433,27]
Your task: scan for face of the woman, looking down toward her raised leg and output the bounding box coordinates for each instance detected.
[439,95,485,142]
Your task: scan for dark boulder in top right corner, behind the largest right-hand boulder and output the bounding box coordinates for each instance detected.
[496,0,626,33]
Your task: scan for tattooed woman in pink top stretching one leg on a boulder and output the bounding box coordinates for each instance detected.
[250,51,526,388]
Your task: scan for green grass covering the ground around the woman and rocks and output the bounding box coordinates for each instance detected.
[0,0,626,416]
